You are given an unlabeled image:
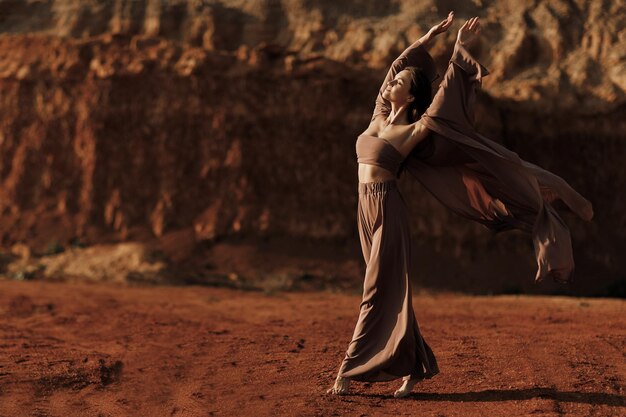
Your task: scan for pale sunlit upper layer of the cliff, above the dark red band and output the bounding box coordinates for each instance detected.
[0,0,626,115]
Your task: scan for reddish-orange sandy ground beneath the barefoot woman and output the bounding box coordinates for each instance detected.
[0,281,626,417]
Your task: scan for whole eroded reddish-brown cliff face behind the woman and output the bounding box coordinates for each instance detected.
[0,0,626,293]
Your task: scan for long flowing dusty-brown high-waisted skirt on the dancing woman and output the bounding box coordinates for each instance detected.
[338,179,439,382]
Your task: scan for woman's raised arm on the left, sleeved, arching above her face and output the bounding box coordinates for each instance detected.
[371,12,454,121]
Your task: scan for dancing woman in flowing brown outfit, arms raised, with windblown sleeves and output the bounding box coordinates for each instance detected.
[327,12,593,397]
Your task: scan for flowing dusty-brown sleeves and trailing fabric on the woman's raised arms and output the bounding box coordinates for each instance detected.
[372,42,593,283]
